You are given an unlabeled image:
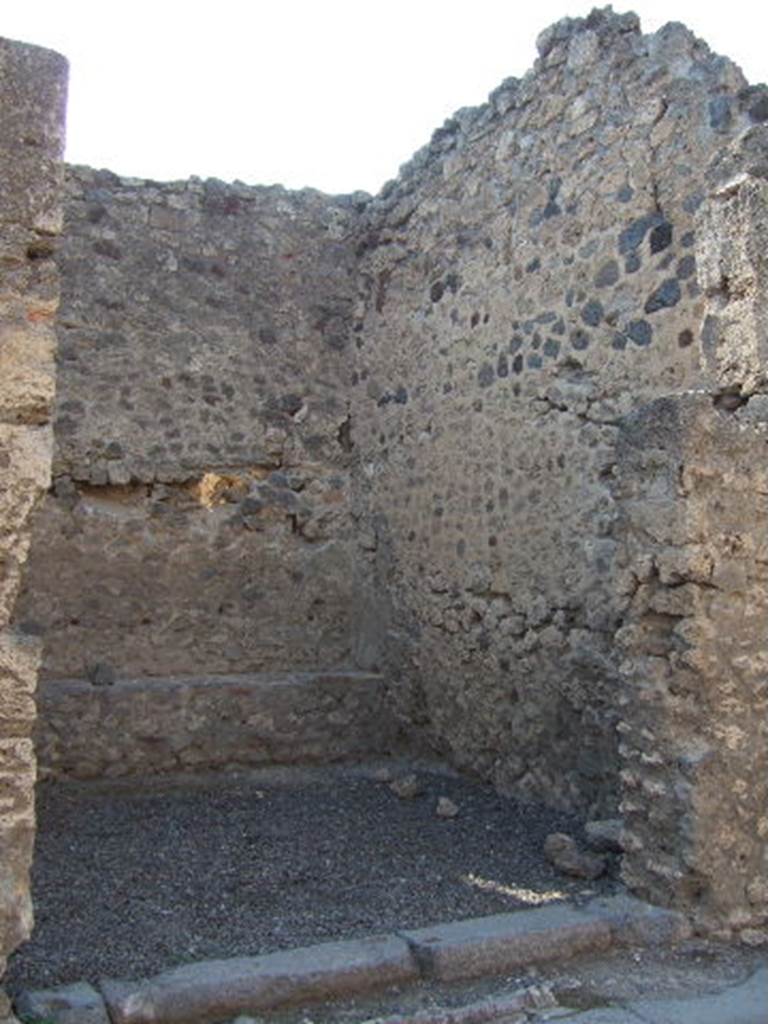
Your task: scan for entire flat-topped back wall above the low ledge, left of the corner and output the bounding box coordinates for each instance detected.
[17,168,357,683]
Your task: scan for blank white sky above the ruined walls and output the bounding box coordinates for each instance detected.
[0,0,768,193]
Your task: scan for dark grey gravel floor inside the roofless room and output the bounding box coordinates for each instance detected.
[6,765,617,991]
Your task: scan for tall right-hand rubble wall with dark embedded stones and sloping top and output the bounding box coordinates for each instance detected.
[351,11,768,813]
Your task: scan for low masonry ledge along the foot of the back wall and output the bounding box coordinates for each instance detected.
[36,672,398,778]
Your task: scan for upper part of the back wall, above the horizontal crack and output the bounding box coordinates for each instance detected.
[54,168,356,486]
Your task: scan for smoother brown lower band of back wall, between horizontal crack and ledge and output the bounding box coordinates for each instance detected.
[16,477,354,679]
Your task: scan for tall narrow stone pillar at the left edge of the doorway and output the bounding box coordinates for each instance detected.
[0,40,67,1020]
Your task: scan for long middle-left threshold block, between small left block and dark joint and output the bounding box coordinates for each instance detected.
[99,936,419,1024]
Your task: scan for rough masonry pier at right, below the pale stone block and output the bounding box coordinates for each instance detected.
[617,394,768,941]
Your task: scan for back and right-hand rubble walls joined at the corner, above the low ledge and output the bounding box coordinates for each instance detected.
[10,11,768,864]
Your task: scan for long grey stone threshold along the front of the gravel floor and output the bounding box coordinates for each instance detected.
[16,895,690,1024]
